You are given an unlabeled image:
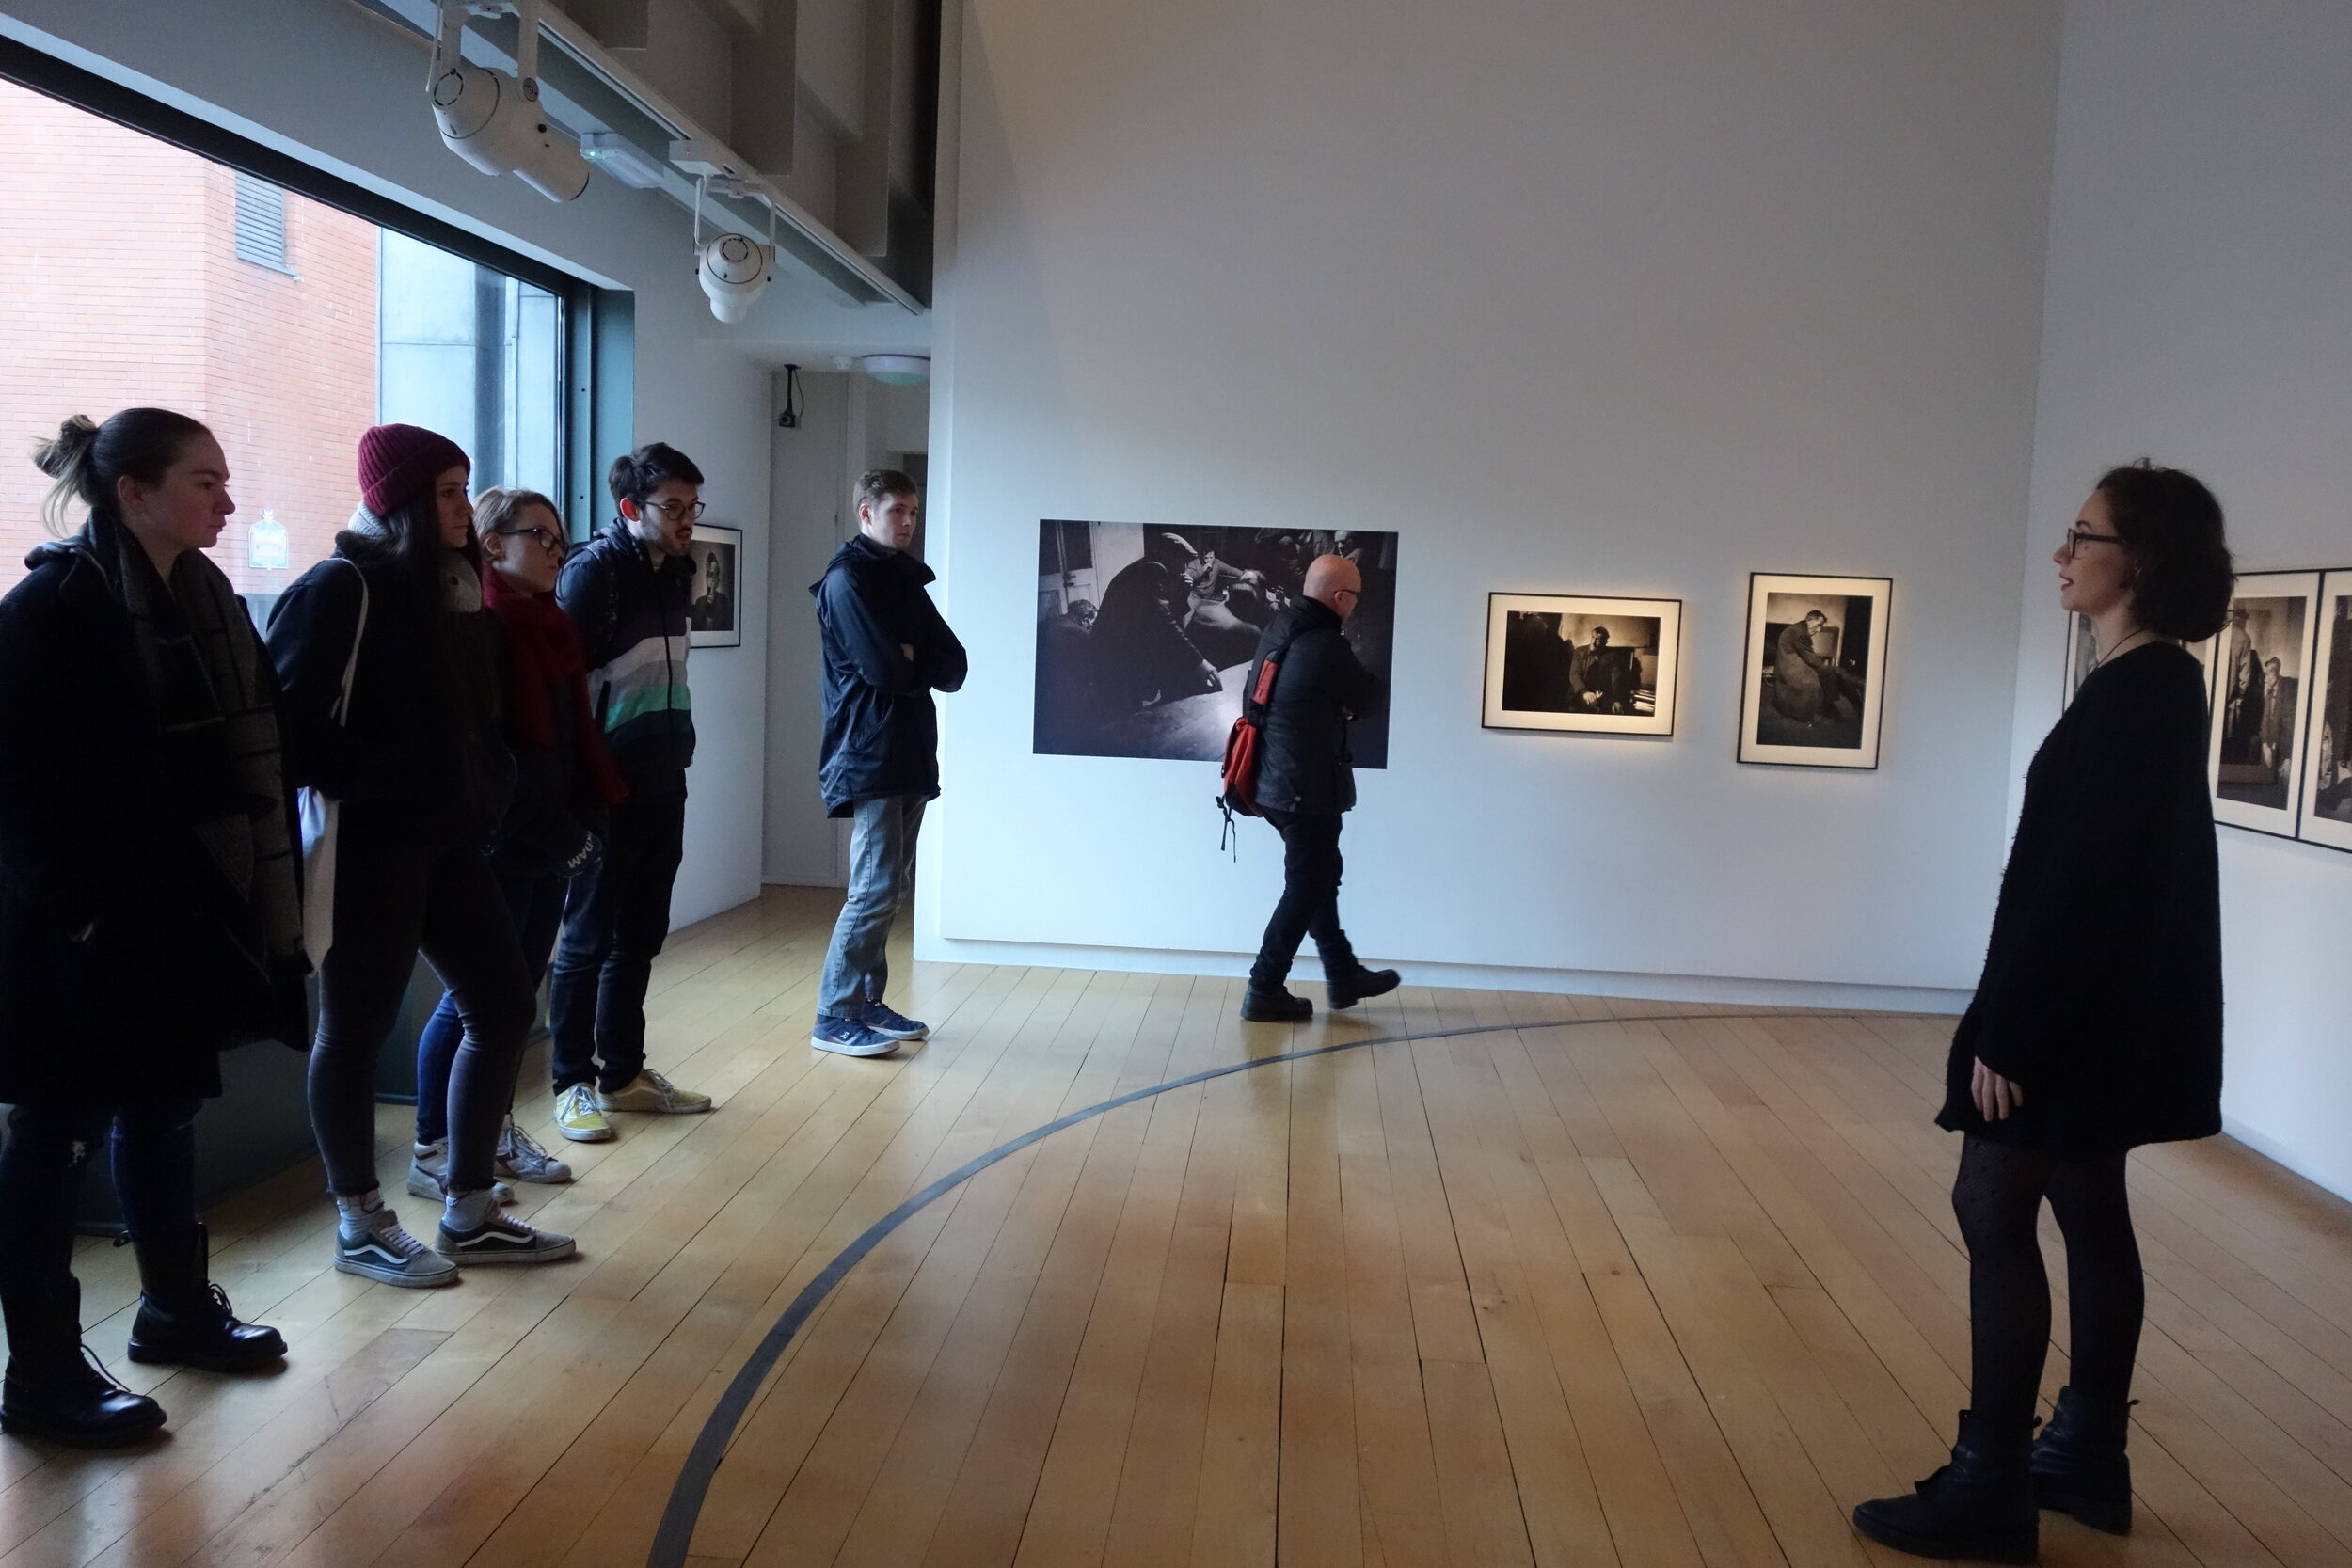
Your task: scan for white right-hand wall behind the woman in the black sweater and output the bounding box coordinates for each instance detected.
[2016,0,2352,1196]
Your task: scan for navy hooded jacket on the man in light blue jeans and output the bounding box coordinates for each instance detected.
[809,533,972,816]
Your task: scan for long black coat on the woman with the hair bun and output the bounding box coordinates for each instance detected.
[0,546,309,1105]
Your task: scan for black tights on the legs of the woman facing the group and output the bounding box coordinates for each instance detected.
[1952,1135,2145,1430]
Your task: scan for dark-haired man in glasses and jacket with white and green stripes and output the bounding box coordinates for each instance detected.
[548,442,710,1143]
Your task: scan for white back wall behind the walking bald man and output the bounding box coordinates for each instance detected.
[917,0,2058,1004]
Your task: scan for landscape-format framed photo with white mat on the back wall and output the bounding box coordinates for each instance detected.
[1480,593,1682,736]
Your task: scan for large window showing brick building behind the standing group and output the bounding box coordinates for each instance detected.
[0,80,567,611]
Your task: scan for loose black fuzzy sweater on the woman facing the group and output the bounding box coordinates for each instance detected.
[1936,644,2220,1159]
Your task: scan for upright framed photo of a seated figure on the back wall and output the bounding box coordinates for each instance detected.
[1740,571,1896,768]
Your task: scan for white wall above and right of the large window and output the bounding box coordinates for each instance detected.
[0,0,828,924]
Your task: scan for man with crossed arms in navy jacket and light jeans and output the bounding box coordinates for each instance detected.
[809,467,967,1055]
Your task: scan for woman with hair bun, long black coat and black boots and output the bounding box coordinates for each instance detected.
[0,409,309,1449]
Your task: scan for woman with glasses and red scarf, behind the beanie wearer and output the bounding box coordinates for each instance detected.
[409,489,628,1196]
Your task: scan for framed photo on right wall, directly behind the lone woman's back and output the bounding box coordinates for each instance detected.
[2206,571,2319,837]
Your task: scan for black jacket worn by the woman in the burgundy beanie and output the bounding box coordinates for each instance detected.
[268,531,516,844]
